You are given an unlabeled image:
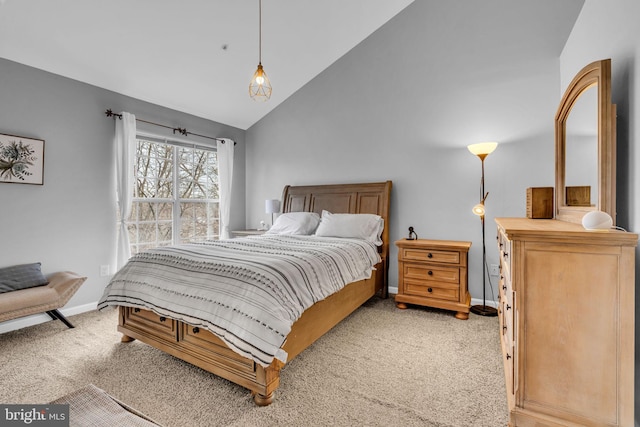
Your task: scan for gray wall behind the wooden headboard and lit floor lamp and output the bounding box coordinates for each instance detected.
[247,1,575,303]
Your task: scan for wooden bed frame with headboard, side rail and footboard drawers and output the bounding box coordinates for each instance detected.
[118,181,391,406]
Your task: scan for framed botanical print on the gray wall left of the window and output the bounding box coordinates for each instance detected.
[0,133,44,185]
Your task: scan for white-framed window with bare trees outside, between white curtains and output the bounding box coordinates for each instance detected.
[129,136,220,254]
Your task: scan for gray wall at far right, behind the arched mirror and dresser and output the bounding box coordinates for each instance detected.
[560,0,640,426]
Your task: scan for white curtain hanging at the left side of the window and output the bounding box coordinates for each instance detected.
[114,112,136,269]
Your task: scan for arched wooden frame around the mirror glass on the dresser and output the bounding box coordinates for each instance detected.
[555,59,616,225]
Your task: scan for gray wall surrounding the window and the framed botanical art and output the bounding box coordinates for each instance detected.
[0,58,245,331]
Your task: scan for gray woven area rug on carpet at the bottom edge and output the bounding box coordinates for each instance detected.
[50,384,164,427]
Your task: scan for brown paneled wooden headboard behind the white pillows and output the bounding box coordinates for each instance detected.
[282,181,391,296]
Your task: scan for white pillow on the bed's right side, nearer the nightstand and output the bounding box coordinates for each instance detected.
[316,211,384,246]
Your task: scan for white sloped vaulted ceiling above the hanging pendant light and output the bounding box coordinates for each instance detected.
[0,0,413,129]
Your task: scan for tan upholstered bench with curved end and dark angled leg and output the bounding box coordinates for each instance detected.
[0,271,87,328]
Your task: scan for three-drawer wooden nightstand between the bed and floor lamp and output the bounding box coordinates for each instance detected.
[396,239,471,320]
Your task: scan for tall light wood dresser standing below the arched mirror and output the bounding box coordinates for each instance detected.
[496,218,638,426]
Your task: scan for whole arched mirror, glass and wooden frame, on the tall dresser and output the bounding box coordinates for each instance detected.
[555,59,616,224]
